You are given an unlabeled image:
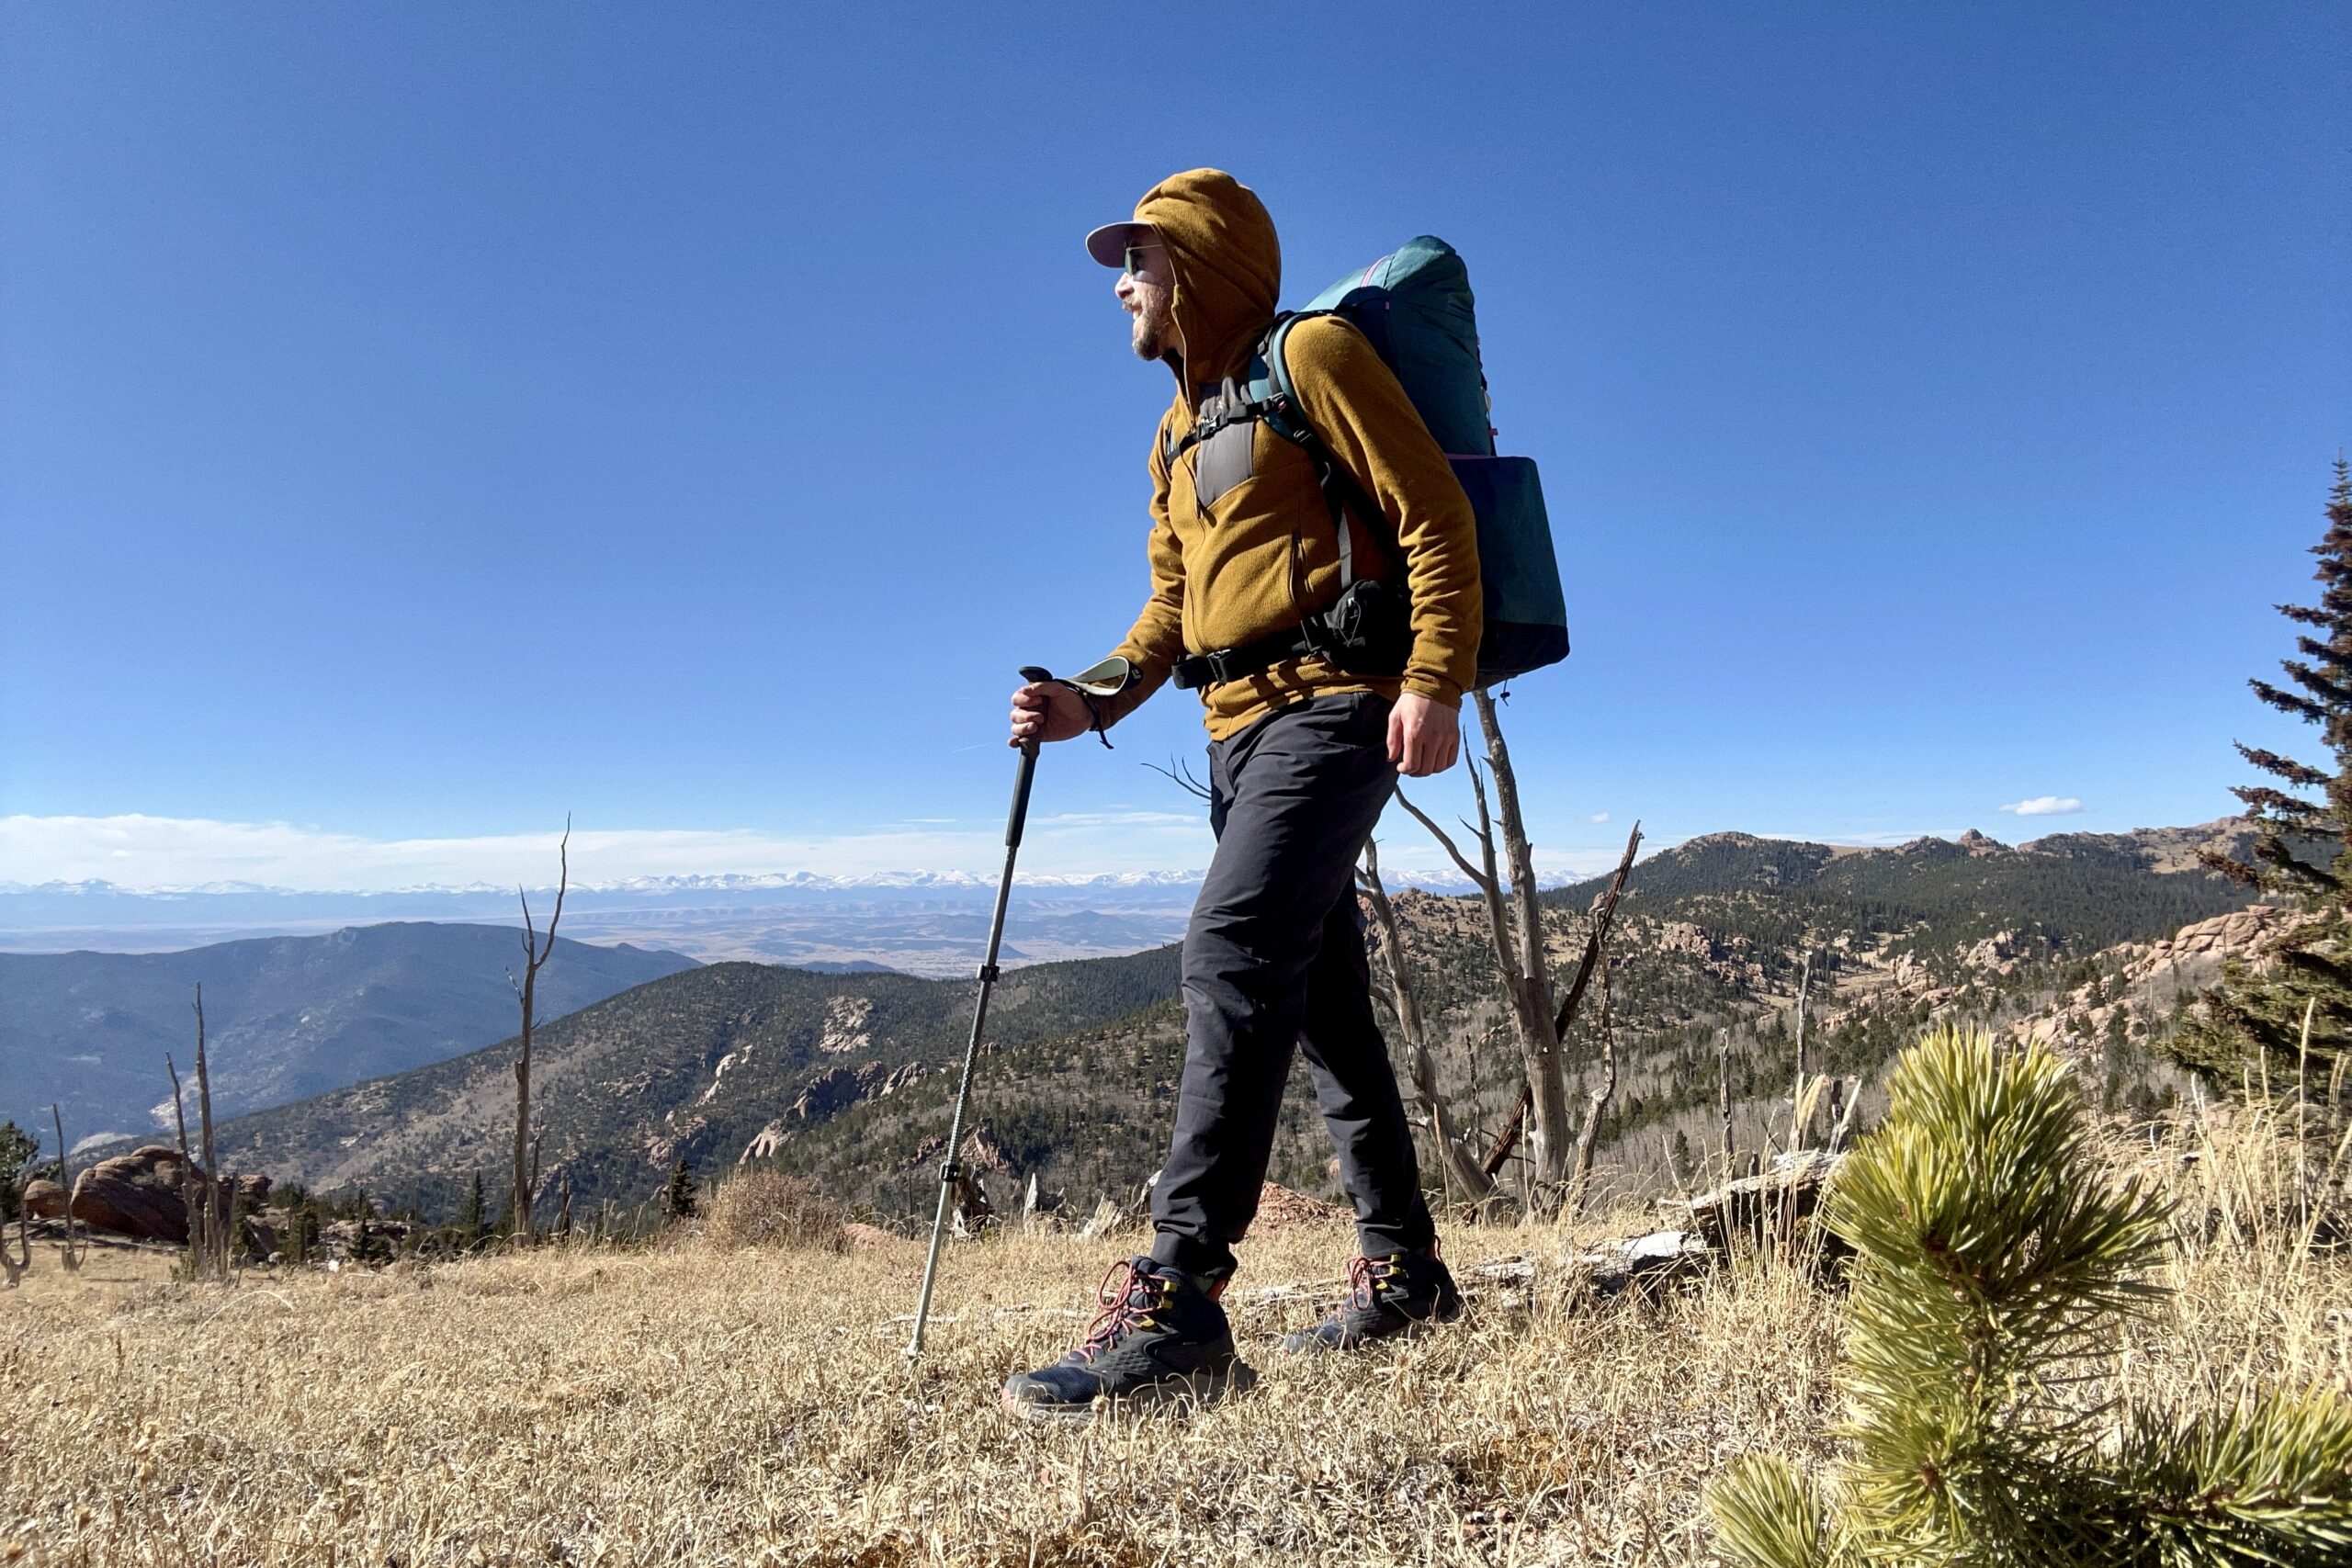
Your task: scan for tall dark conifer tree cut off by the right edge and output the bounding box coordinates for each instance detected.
[2171,458,2352,1084]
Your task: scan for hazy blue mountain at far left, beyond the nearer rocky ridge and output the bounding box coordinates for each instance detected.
[0,921,696,1143]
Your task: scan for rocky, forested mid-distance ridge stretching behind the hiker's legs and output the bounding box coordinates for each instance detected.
[141,823,2246,1215]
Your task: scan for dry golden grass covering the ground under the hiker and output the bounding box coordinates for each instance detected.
[0,1109,2352,1568]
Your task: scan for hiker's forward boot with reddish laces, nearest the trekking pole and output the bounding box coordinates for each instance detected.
[1004,1258,1259,1420]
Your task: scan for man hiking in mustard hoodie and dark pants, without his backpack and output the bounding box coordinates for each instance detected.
[1004,169,1482,1416]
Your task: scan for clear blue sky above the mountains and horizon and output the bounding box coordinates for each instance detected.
[0,5,2352,886]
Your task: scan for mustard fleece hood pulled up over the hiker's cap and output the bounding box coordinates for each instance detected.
[1136,169,1282,407]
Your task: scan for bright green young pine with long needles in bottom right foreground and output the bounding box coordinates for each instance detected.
[1708,1030,2352,1568]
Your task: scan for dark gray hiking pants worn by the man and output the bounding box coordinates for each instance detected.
[1152,694,1435,1274]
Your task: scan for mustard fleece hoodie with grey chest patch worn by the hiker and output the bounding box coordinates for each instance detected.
[1103,169,1484,740]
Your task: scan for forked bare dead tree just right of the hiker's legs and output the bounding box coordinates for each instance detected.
[1397,709,1642,1211]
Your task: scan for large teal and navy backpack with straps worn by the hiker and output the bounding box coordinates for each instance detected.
[1169,235,1569,686]
